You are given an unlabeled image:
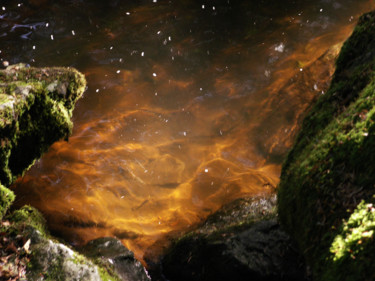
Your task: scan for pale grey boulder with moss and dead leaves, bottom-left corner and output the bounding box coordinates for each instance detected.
[0,206,120,281]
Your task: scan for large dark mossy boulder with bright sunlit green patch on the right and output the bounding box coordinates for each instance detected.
[278,12,375,281]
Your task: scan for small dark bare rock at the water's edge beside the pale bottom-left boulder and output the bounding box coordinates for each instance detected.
[81,237,151,281]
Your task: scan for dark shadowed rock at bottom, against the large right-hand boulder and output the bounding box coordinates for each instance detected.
[162,197,306,281]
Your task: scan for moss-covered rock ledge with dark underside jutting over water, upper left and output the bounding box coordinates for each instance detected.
[0,64,86,186]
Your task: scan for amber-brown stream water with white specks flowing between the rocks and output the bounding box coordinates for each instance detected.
[0,0,375,259]
